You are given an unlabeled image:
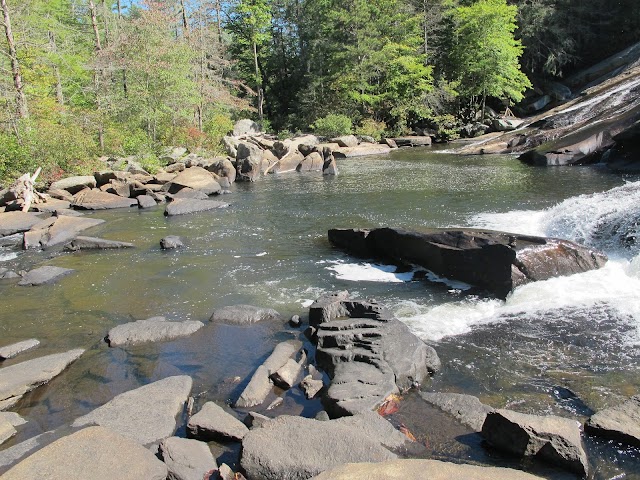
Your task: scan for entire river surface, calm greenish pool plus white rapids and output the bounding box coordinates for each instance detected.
[0,149,640,479]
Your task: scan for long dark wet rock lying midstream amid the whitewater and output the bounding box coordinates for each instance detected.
[329,228,607,298]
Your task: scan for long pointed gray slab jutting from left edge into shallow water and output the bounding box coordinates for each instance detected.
[0,349,84,410]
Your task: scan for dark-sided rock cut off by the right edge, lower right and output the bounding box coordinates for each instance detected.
[584,395,640,447]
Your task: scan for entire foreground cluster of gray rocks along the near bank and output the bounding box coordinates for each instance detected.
[0,292,640,480]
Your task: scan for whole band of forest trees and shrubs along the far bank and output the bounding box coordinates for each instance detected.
[0,0,640,186]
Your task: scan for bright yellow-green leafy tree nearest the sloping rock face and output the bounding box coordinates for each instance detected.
[448,0,531,118]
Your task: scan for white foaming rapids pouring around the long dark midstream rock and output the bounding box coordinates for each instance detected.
[333,182,640,345]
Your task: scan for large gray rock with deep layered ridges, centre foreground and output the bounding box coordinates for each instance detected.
[309,292,440,417]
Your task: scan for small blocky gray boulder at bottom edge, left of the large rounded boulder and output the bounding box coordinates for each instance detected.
[160,437,218,480]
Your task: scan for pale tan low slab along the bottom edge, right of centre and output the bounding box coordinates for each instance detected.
[313,459,542,480]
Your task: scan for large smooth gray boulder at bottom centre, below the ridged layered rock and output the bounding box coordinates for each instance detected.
[241,413,406,480]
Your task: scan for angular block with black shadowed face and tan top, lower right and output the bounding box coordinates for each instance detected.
[482,410,588,475]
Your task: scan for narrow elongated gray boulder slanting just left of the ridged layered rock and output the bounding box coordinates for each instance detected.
[235,340,302,408]
